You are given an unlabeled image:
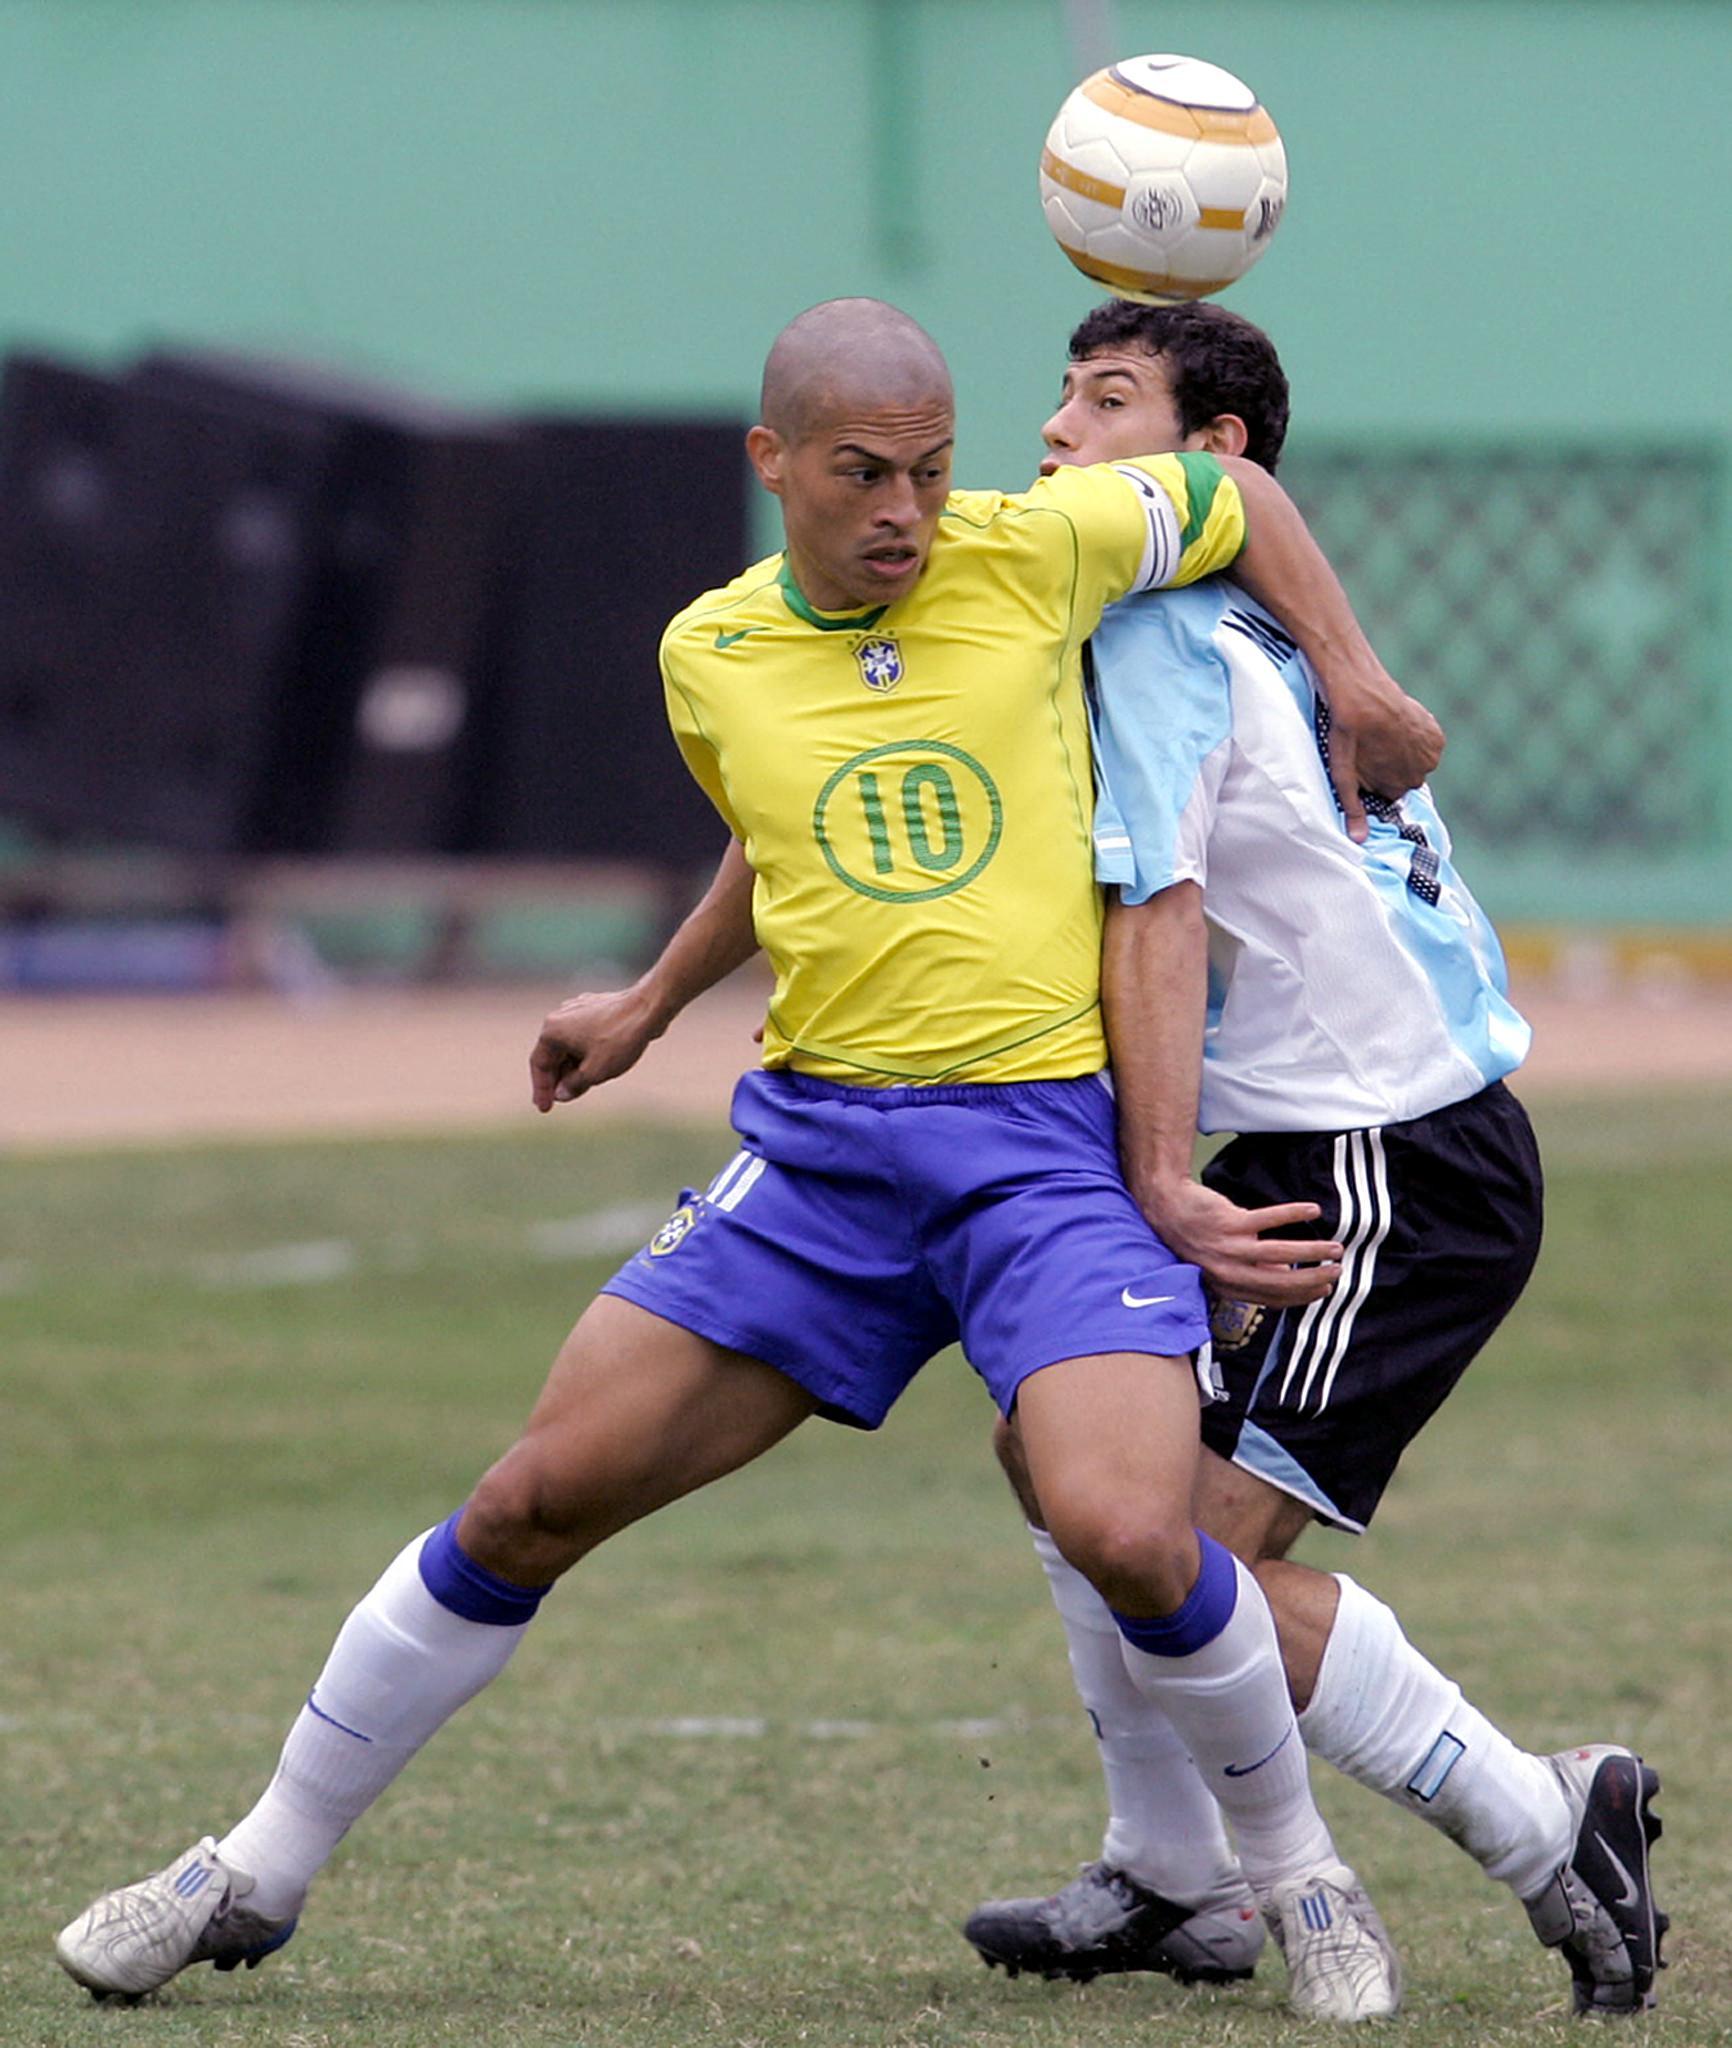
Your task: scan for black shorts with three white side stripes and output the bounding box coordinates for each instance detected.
[1202,1081,1544,1530]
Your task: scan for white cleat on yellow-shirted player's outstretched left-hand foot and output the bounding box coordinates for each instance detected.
[53,1835,295,2001]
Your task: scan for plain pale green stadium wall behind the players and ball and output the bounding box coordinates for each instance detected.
[0,0,1732,920]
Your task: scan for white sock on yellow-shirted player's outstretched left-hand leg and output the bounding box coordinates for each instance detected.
[217,1536,528,1919]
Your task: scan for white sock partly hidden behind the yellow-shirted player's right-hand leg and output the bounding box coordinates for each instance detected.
[1028,1528,1245,1907]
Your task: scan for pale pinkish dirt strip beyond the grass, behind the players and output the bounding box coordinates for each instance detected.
[0,969,1732,1151]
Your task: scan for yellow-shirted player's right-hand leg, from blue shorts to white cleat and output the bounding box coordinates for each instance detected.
[1003,1356,1400,2019]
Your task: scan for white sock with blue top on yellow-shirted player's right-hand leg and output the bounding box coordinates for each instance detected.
[1120,1538,1339,1892]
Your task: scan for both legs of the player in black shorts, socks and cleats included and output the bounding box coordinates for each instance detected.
[970,1427,1666,2011]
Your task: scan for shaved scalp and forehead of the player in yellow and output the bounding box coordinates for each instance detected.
[760,299,956,444]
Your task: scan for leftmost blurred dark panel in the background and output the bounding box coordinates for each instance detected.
[0,358,334,852]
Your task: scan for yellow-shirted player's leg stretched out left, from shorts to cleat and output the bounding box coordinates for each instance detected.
[55,1294,813,1999]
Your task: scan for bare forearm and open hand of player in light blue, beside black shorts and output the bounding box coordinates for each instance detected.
[1101,881,1341,1309]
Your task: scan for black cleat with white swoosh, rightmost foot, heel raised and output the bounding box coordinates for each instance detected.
[1525,1743,1671,2015]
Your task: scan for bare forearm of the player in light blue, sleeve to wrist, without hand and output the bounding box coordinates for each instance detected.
[1101,883,1208,1217]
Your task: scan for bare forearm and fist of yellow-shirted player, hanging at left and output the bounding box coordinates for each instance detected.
[530,840,757,1110]
